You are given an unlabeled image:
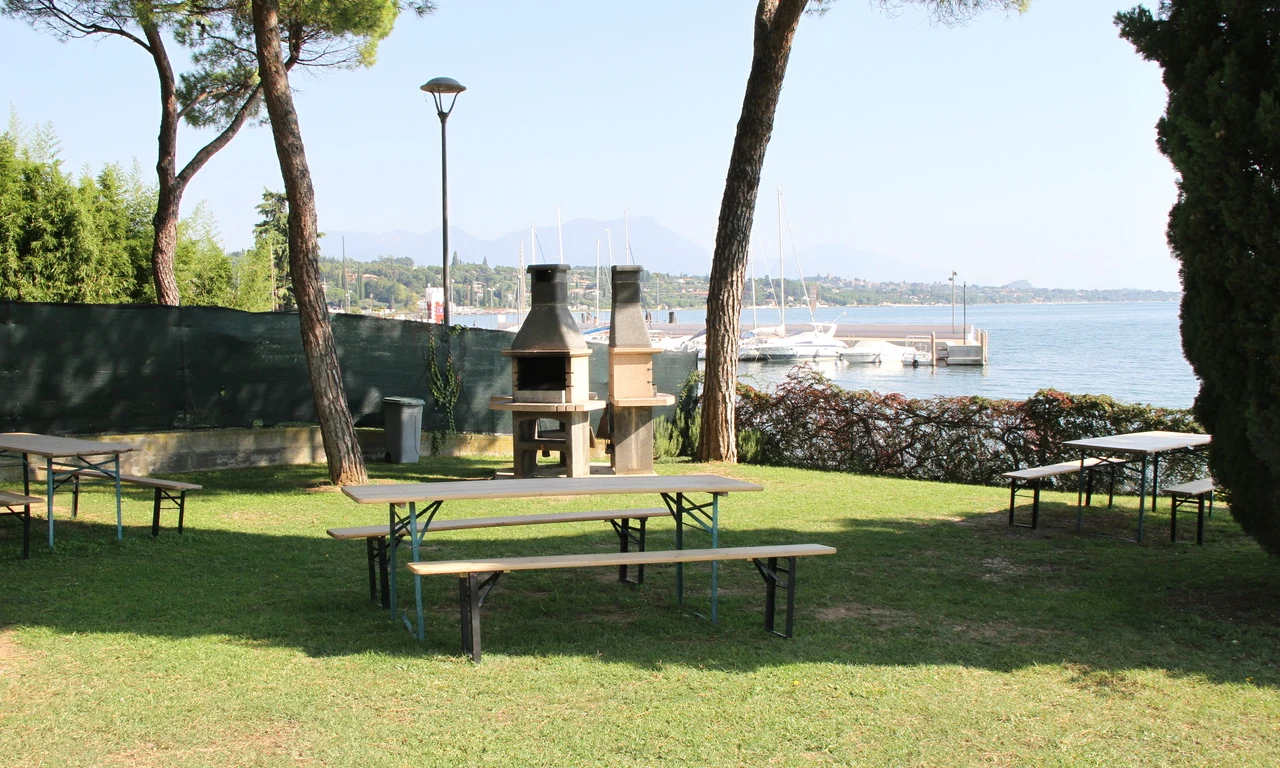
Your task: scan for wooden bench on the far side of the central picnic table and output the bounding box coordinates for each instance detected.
[328,507,671,608]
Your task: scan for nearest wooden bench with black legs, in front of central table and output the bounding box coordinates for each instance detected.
[408,544,836,663]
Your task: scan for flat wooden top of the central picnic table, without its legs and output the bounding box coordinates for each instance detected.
[342,475,764,504]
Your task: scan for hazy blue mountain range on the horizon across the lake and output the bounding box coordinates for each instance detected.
[320,216,937,282]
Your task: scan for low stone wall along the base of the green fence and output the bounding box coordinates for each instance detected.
[0,426,604,481]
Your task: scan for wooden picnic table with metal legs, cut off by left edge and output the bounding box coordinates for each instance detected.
[0,433,138,549]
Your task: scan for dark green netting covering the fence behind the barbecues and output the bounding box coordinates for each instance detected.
[0,302,696,434]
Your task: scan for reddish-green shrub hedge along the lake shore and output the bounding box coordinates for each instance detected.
[737,366,1204,489]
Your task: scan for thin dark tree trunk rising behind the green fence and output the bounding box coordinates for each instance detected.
[142,22,184,306]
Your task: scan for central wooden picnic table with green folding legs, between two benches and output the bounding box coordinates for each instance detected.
[342,475,764,640]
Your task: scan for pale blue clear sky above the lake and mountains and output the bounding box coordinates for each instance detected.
[0,0,1178,289]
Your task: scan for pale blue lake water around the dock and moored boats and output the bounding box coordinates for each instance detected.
[458,302,1199,408]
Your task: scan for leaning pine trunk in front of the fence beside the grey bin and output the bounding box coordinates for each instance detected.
[252,0,369,485]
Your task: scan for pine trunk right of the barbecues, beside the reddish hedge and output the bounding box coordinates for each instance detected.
[698,0,808,462]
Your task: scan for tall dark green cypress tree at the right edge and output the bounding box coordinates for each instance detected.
[1116,0,1280,554]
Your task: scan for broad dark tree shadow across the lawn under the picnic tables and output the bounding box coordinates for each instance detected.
[0,483,1280,686]
